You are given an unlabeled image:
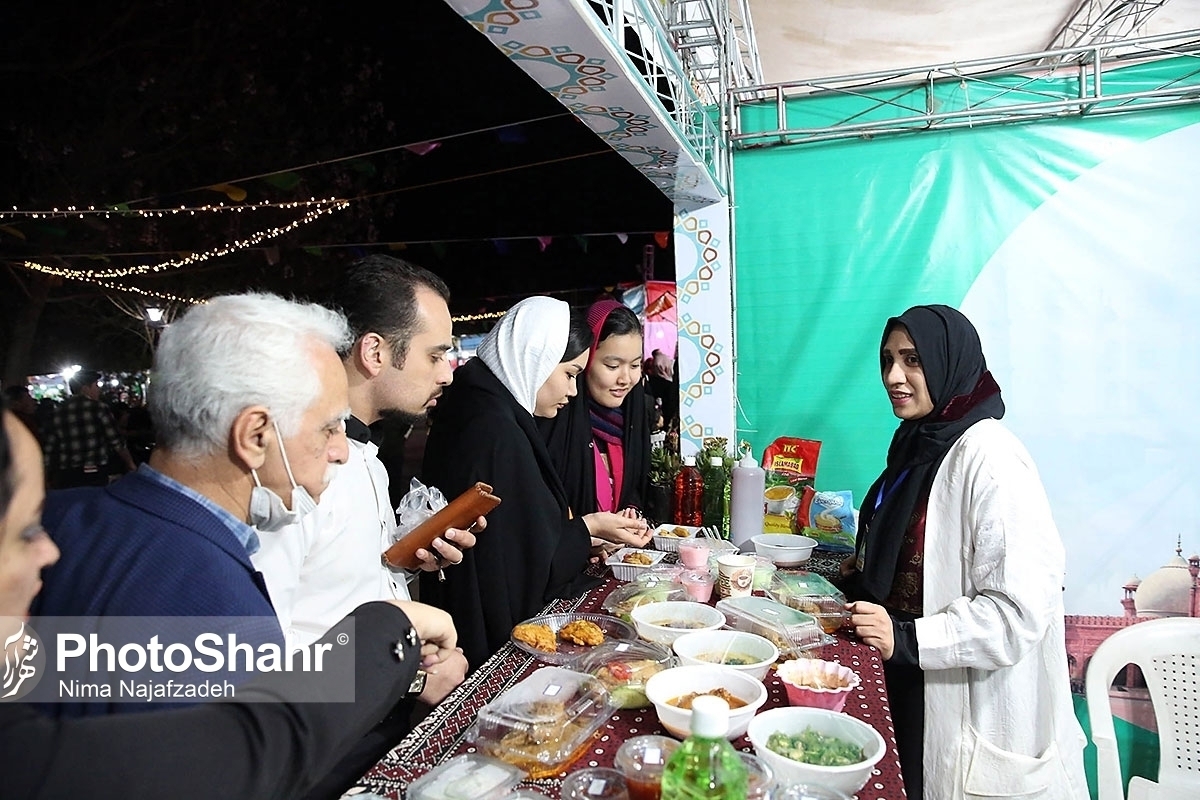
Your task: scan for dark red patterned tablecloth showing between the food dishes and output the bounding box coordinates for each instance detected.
[361,578,905,800]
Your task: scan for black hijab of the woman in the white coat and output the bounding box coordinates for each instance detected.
[858,306,1004,602]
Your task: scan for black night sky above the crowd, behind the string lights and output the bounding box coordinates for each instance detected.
[0,0,672,371]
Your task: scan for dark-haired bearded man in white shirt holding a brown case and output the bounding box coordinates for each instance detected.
[253,255,485,705]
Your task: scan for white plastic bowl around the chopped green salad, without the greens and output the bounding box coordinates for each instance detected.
[744,705,887,794]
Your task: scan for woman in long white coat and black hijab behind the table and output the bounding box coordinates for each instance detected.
[842,306,1087,800]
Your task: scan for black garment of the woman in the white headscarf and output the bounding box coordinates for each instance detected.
[420,359,595,669]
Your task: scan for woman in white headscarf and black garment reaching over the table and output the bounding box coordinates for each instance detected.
[420,297,649,668]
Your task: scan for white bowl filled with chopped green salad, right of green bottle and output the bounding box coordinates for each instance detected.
[746,705,887,794]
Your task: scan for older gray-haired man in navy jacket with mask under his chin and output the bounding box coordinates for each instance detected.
[32,294,349,700]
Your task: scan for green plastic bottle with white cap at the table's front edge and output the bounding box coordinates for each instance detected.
[662,694,748,800]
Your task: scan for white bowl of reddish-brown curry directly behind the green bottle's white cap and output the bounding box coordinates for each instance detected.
[646,664,767,740]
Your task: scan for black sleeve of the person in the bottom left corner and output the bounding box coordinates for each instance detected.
[0,603,420,800]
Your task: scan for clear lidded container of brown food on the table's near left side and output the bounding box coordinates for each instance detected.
[467,667,616,778]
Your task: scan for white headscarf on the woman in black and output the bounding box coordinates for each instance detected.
[475,296,571,415]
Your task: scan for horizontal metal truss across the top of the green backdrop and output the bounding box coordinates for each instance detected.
[730,30,1200,149]
